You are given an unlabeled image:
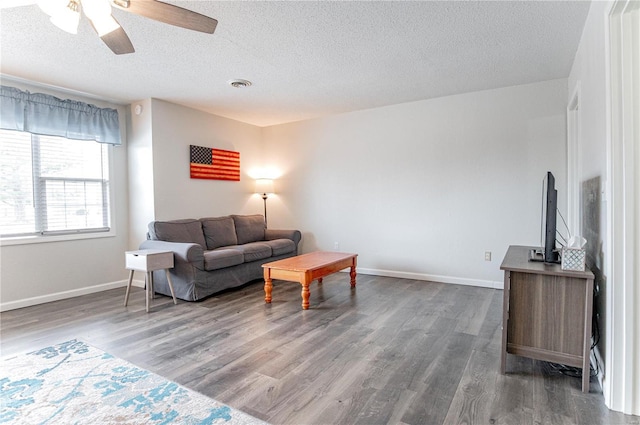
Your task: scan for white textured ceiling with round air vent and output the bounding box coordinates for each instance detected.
[0,0,589,126]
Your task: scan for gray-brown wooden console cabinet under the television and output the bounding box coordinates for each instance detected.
[500,246,593,392]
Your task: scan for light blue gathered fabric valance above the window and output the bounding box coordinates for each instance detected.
[0,86,122,145]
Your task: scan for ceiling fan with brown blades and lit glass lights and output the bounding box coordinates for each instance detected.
[7,0,218,55]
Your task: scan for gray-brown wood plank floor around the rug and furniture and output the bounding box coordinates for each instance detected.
[0,273,640,425]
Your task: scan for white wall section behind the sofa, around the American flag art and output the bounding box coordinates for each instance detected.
[129,99,262,245]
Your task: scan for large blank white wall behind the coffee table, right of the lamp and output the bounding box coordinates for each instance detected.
[264,79,567,287]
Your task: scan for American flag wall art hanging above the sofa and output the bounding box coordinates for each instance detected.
[189,145,240,181]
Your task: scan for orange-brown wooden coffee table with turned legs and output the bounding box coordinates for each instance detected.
[262,251,358,310]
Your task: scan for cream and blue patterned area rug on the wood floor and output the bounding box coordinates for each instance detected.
[0,340,265,425]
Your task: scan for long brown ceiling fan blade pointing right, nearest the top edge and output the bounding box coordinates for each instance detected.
[113,0,218,34]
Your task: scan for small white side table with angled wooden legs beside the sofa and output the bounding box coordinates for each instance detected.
[124,249,178,313]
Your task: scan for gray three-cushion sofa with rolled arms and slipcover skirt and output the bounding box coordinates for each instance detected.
[140,215,302,301]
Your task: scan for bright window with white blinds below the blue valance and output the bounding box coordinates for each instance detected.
[0,130,110,237]
